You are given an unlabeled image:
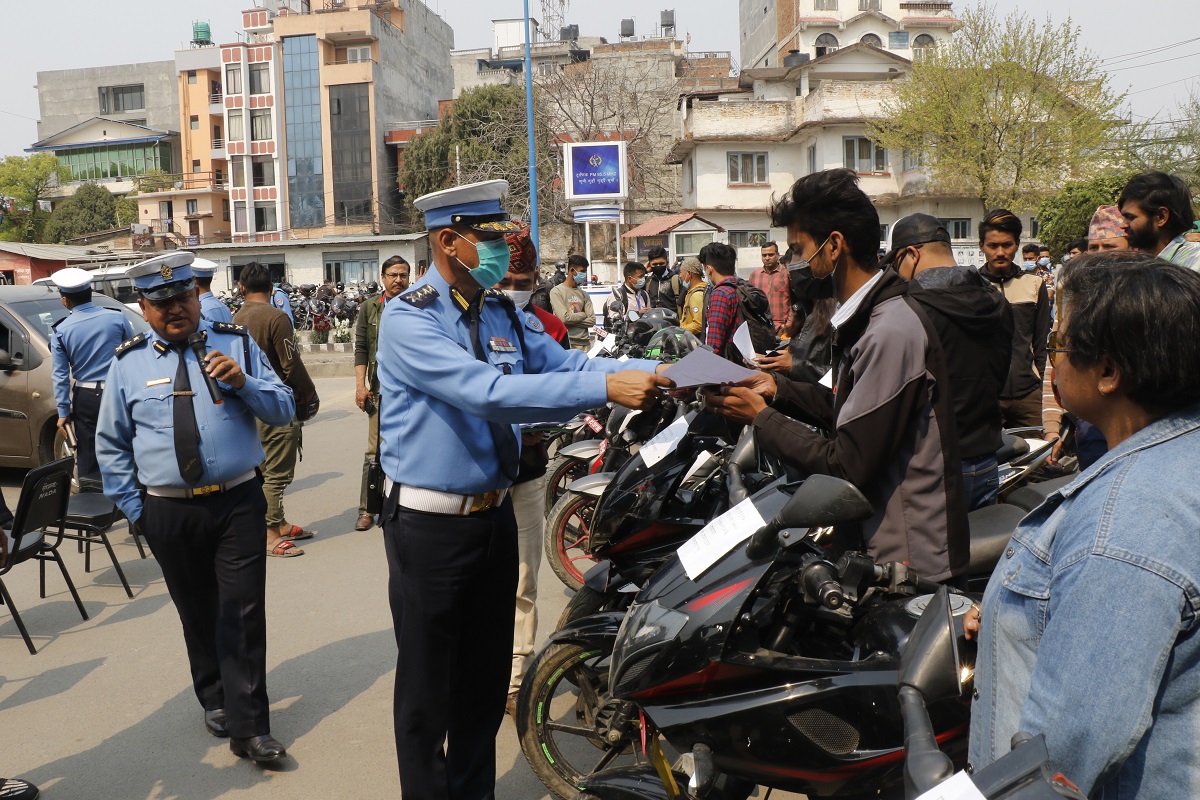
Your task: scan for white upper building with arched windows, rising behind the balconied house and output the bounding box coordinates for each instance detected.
[738,0,960,70]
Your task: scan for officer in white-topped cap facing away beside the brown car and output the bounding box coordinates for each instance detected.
[50,266,133,479]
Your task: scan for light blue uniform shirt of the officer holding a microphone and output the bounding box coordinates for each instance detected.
[96,319,295,519]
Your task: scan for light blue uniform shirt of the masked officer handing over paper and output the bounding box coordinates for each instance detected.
[377,269,658,494]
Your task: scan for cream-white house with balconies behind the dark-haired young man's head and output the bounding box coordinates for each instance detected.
[667,43,1022,267]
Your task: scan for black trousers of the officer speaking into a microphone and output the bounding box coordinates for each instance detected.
[140,480,271,739]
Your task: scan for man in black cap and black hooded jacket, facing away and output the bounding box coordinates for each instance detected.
[884,213,1013,510]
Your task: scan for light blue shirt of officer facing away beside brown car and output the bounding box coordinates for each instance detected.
[50,302,133,417]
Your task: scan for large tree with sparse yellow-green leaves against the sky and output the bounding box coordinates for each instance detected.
[871,5,1128,211]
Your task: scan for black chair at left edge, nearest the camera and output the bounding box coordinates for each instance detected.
[0,458,88,655]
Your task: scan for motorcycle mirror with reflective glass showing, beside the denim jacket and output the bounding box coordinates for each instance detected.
[896,587,962,703]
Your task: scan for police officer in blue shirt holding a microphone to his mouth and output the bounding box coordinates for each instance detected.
[96,252,295,764]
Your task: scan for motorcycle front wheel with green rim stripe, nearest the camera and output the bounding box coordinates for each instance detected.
[514,642,644,800]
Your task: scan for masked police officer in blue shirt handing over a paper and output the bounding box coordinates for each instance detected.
[378,181,667,800]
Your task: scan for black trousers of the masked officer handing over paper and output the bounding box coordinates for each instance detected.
[383,498,517,800]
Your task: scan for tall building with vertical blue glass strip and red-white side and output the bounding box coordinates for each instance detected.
[221,0,454,242]
